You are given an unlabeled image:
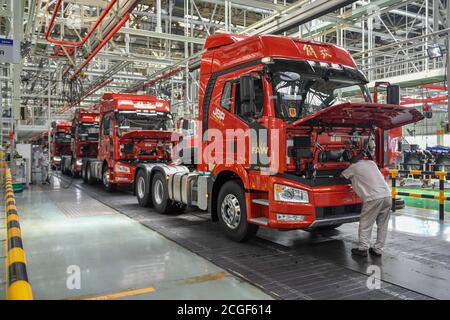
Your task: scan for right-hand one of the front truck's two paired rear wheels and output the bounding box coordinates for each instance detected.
[151,172,186,214]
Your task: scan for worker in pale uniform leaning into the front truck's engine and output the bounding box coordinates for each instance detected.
[342,157,392,257]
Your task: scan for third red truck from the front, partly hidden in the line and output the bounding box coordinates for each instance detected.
[61,109,100,179]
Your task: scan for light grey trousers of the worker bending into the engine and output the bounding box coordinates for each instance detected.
[358,197,392,253]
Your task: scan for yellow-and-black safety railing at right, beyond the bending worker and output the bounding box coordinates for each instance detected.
[389,169,450,221]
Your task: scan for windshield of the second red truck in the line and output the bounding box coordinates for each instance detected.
[116,111,174,135]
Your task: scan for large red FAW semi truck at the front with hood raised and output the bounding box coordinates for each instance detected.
[135,34,423,241]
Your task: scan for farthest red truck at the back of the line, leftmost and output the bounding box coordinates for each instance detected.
[50,120,72,169]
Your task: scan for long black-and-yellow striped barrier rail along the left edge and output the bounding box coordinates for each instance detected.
[0,162,33,300]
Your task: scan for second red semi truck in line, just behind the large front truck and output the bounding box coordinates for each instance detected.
[82,93,174,191]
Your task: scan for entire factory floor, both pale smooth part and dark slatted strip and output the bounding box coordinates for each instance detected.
[0,172,450,299]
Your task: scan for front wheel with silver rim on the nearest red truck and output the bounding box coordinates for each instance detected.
[217,181,259,242]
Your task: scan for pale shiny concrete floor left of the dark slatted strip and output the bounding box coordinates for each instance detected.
[0,179,273,300]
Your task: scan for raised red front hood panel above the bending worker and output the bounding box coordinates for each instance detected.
[290,102,424,130]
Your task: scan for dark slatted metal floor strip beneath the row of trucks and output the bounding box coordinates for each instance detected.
[58,178,450,299]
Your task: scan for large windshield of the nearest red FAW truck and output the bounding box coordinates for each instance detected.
[271,61,371,122]
